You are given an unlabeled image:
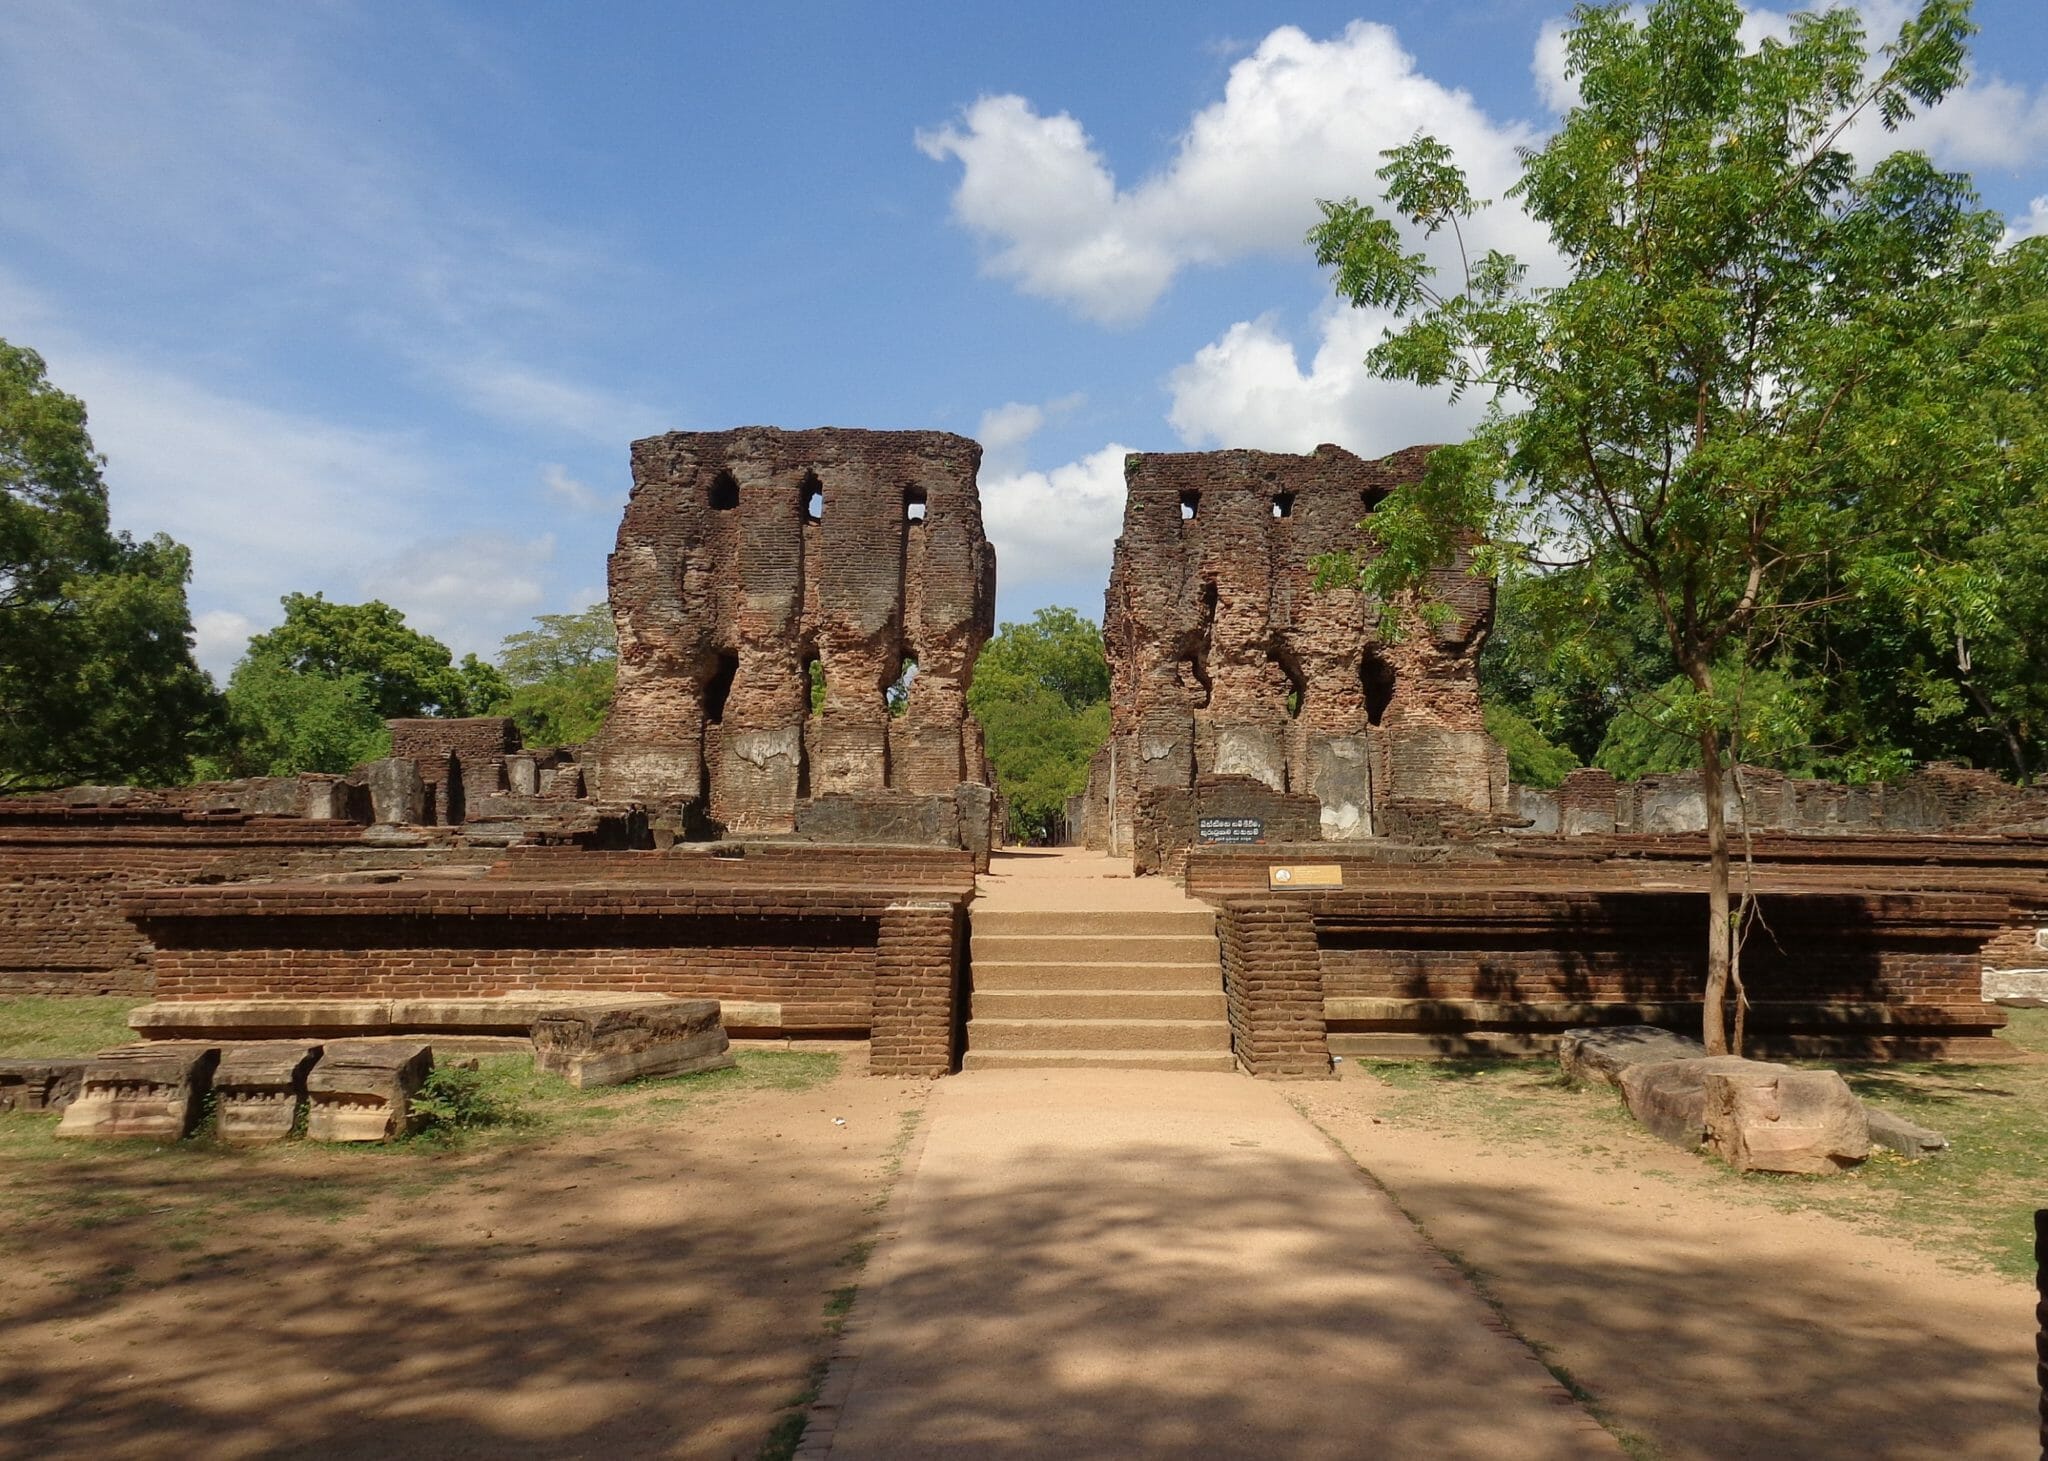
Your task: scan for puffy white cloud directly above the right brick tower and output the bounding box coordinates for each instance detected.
[1167,309,1483,457]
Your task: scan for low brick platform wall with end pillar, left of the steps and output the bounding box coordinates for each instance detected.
[125,852,973,1076]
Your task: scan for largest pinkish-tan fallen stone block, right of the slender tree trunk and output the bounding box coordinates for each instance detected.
[1704,1061,1870,1174]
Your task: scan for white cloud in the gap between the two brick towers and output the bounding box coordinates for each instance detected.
[981,443,1130,598]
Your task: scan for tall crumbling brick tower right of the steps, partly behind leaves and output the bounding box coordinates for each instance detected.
[1090,447,1507,852]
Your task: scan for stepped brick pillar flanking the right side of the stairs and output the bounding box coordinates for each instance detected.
[1219,898,1331,1078]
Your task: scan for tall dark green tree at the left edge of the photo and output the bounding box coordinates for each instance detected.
[0,340,219,791]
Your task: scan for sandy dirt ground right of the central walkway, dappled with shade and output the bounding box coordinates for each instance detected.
[1288,1068,2040,1461]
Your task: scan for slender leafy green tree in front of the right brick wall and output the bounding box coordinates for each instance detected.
[1311,0,2009,1051]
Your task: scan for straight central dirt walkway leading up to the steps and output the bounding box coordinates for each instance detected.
[807,1070,1620,1461]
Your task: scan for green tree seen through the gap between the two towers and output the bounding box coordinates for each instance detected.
[967,609,1110,840]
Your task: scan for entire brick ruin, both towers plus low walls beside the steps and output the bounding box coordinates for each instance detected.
[0,428,2048,1076]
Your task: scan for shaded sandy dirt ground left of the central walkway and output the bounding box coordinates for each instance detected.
[0,1051,930,1461]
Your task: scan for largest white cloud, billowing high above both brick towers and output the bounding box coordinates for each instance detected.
[918,20,1538,324]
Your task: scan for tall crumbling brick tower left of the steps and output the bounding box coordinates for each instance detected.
[590,426,995,834]
